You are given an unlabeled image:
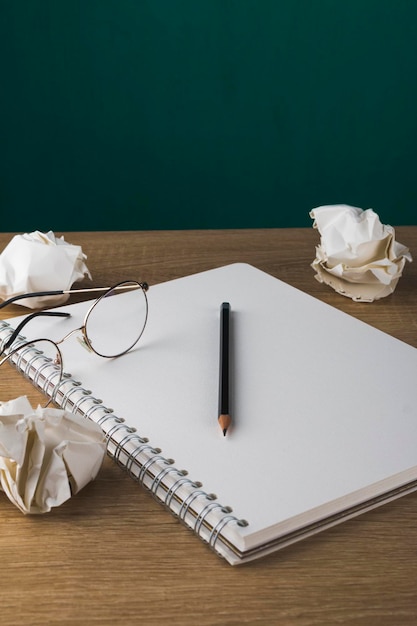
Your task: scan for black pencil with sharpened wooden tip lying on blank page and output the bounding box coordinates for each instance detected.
[218,302,232,436]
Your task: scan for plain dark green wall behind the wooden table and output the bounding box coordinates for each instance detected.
[0,0,417,232]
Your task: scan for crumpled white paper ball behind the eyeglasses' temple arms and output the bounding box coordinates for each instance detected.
[0,230,91,309]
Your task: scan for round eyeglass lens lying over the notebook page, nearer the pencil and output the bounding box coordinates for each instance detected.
[85,281,148,357]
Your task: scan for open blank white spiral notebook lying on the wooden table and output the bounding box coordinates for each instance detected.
[0,263,417,564]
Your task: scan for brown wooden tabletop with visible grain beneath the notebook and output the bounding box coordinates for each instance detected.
[0,226,417,626]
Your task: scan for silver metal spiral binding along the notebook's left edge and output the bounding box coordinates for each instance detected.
[0,322,248,554]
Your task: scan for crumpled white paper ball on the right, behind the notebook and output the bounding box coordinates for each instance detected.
[310,204,412,302]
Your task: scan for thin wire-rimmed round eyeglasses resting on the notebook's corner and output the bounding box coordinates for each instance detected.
[0,280,149,402]
